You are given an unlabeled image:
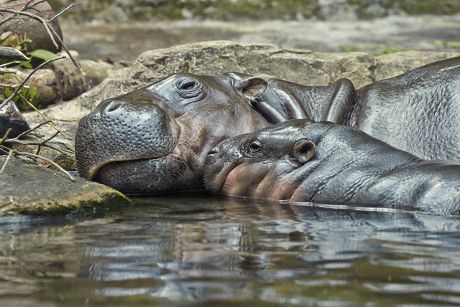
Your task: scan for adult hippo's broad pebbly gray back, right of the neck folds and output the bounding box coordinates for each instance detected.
[348,57,460,160]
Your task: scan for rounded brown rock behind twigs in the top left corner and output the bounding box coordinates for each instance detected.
[0,0,62,52]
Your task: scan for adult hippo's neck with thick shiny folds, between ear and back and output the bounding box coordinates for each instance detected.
[262,79,356,124]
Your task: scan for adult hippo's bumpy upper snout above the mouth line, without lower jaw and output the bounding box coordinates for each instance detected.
[75,91,180,183]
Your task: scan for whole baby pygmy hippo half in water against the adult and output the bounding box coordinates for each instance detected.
[204,120,460,214]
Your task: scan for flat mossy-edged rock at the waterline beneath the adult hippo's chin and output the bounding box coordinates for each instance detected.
[0,156,129,214]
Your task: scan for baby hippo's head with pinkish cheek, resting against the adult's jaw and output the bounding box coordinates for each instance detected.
[204,120,329,200]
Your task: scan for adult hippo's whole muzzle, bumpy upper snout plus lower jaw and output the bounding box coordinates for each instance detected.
[75,90,194,194]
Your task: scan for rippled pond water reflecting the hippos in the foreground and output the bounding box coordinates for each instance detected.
[0,195,460,306]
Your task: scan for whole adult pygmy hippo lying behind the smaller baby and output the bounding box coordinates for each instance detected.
[76,58,460,194]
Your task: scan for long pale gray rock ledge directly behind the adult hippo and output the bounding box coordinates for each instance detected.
[36,41,460,121]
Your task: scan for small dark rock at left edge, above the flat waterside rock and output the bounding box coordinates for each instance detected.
[0,102,29,141]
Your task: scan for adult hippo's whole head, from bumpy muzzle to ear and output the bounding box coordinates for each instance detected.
[76,74,269,194]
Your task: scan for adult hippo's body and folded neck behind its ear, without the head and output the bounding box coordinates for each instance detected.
[235,57,460,160]
